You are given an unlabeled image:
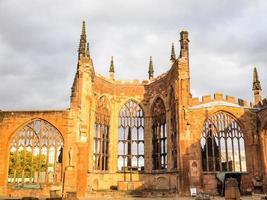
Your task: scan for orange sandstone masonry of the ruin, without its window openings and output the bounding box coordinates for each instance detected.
[0,20,267,199]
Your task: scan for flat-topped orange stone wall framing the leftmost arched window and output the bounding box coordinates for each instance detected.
[0,111,68,195]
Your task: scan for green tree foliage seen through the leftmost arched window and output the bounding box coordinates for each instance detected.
[8,150,46,178]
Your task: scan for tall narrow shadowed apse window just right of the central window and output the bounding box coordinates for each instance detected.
[152,98,167,170]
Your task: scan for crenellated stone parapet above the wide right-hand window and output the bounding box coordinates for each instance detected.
[190,92,252,108]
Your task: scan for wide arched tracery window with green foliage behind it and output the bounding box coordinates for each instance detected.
[8,119,63,184]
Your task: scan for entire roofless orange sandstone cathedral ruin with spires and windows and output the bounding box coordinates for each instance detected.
[0,22,267,197]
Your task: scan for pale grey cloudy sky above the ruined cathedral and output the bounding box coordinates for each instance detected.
[0,0,267,110]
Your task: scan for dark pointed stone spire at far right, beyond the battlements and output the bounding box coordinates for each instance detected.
[252,67,262,106]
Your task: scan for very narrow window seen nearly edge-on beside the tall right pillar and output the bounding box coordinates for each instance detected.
[169,88,177,169]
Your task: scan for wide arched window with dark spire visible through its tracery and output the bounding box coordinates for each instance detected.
[200,112,246,172]
